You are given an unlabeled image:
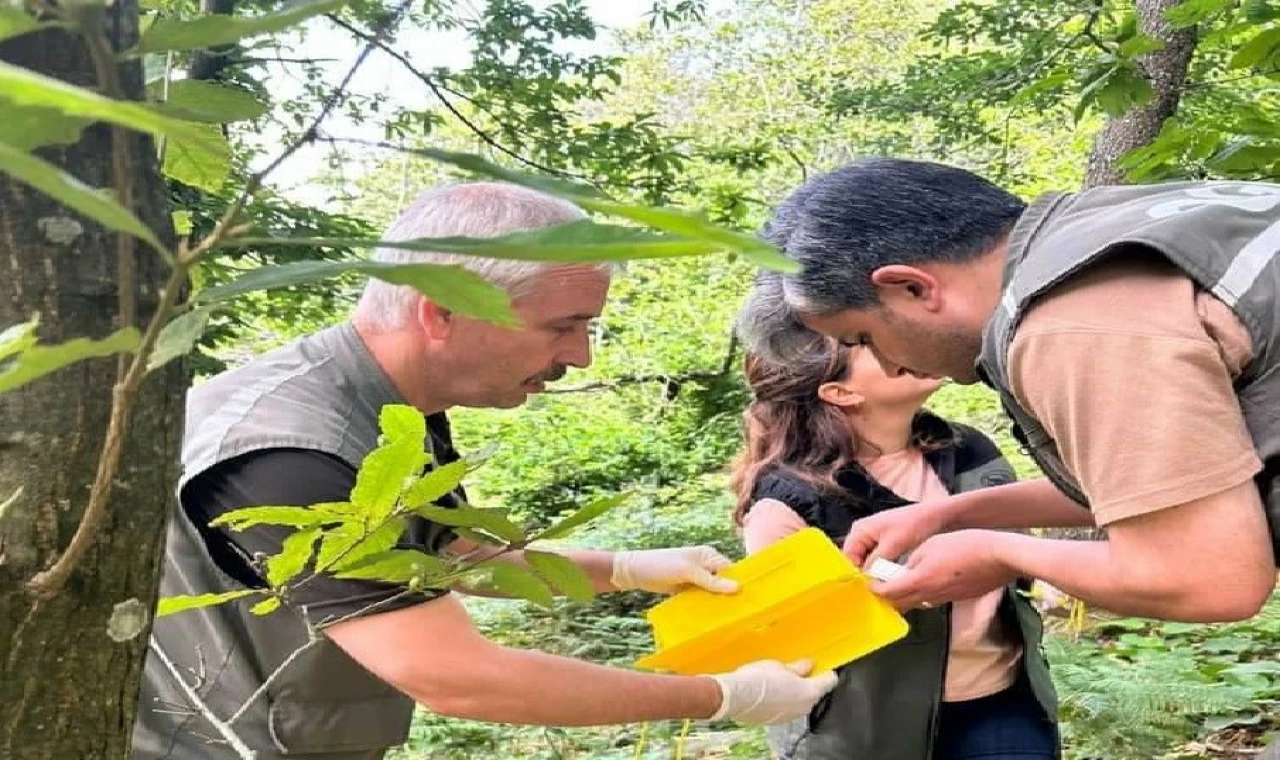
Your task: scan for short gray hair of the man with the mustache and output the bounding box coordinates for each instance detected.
[352,182,599,330]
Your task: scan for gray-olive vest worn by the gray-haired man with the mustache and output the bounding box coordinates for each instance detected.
[132,324,453,760]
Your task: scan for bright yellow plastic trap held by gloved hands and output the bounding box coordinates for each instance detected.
[636,527,908,676]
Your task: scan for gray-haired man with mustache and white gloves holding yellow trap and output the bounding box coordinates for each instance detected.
[132,183,835,760]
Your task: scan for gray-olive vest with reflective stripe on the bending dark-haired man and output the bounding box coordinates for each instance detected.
[978,182,1280,557]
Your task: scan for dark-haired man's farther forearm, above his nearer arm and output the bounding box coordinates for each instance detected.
[943,479,1093,530]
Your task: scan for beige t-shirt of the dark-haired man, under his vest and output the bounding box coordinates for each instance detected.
[1009,252,1262,525]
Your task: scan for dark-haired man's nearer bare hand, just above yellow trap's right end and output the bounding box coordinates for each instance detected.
[872,530,1018,610]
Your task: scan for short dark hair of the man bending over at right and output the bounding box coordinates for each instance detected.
[762,159,1027,313]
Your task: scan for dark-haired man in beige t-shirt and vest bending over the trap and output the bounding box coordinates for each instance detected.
[740,159,1280,622]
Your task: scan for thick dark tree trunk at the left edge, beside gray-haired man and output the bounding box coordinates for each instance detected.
[0,0,189,760]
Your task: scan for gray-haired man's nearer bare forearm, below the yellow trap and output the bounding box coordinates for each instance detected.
[411,647,721,725]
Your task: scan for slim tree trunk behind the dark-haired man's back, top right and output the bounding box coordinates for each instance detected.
[1084,0,1196,187]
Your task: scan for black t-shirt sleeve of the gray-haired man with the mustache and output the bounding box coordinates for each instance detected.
[182,449,445,624]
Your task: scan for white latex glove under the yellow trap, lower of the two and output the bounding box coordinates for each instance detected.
[710,660,837,724]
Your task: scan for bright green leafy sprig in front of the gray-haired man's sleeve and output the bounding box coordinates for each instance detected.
[158,401,621,614]
